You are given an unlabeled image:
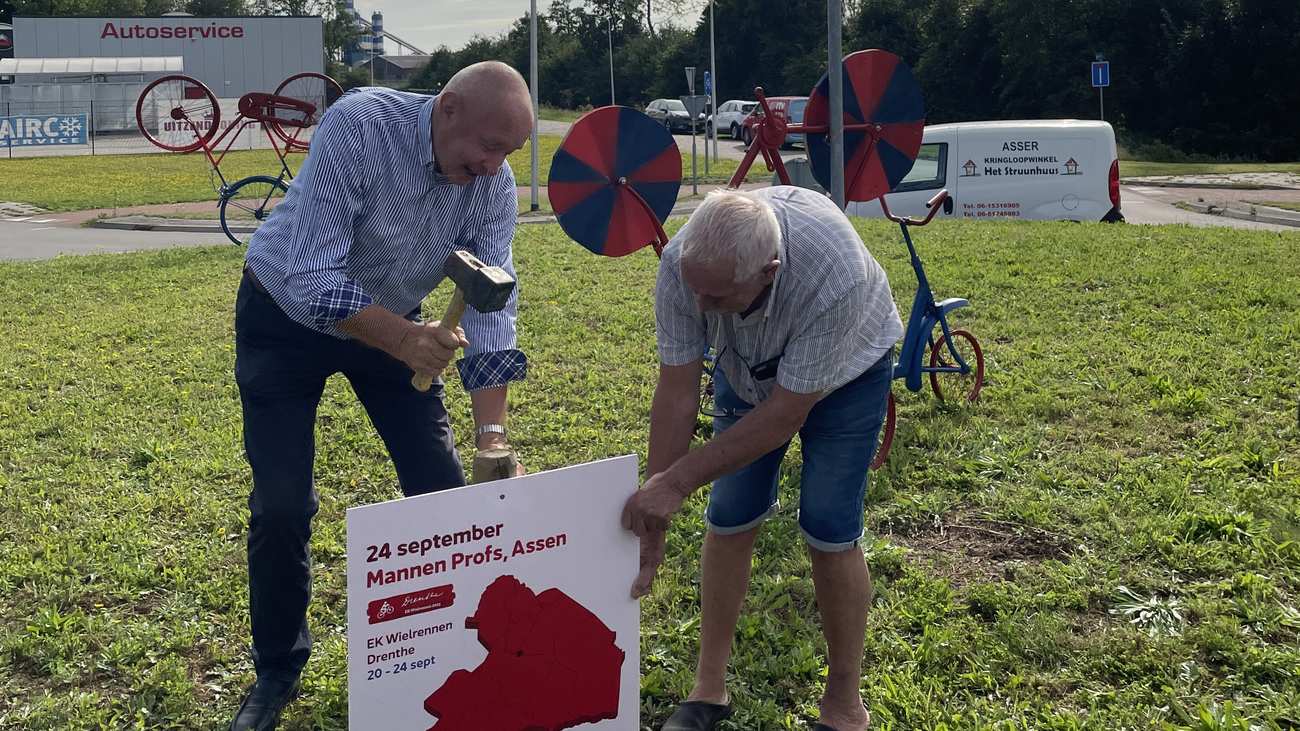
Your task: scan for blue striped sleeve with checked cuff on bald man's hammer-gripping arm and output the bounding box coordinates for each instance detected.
[285,107,373,332]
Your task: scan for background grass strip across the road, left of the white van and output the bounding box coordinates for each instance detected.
[0,135,771,211]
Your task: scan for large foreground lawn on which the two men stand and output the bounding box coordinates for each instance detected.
[0,222,1300,731]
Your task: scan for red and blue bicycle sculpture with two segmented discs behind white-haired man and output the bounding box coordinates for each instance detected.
[549,49,984,467]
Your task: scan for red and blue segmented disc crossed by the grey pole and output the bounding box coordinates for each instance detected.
[803,48,926,200]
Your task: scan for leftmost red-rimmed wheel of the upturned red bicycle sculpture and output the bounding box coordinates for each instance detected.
[135,74,221,152]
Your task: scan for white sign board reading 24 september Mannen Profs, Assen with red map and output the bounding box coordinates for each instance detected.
[347,455,641,731]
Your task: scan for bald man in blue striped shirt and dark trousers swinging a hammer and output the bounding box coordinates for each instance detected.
[231,62,533,731]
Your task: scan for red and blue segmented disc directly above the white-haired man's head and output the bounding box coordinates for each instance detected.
[546,107,681,256]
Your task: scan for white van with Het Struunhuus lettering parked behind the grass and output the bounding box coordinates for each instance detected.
[846,120,1125,221]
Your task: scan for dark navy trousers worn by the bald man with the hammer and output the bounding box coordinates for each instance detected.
[235,273,465,676]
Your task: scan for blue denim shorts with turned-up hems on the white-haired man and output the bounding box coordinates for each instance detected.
[706,349,893,552]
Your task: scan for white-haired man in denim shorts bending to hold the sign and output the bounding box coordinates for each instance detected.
[623,187,902,731]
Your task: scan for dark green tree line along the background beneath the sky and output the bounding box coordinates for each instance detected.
[411,0,1300,160]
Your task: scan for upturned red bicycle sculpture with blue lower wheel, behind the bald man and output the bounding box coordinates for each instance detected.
[135,72,343,245]
